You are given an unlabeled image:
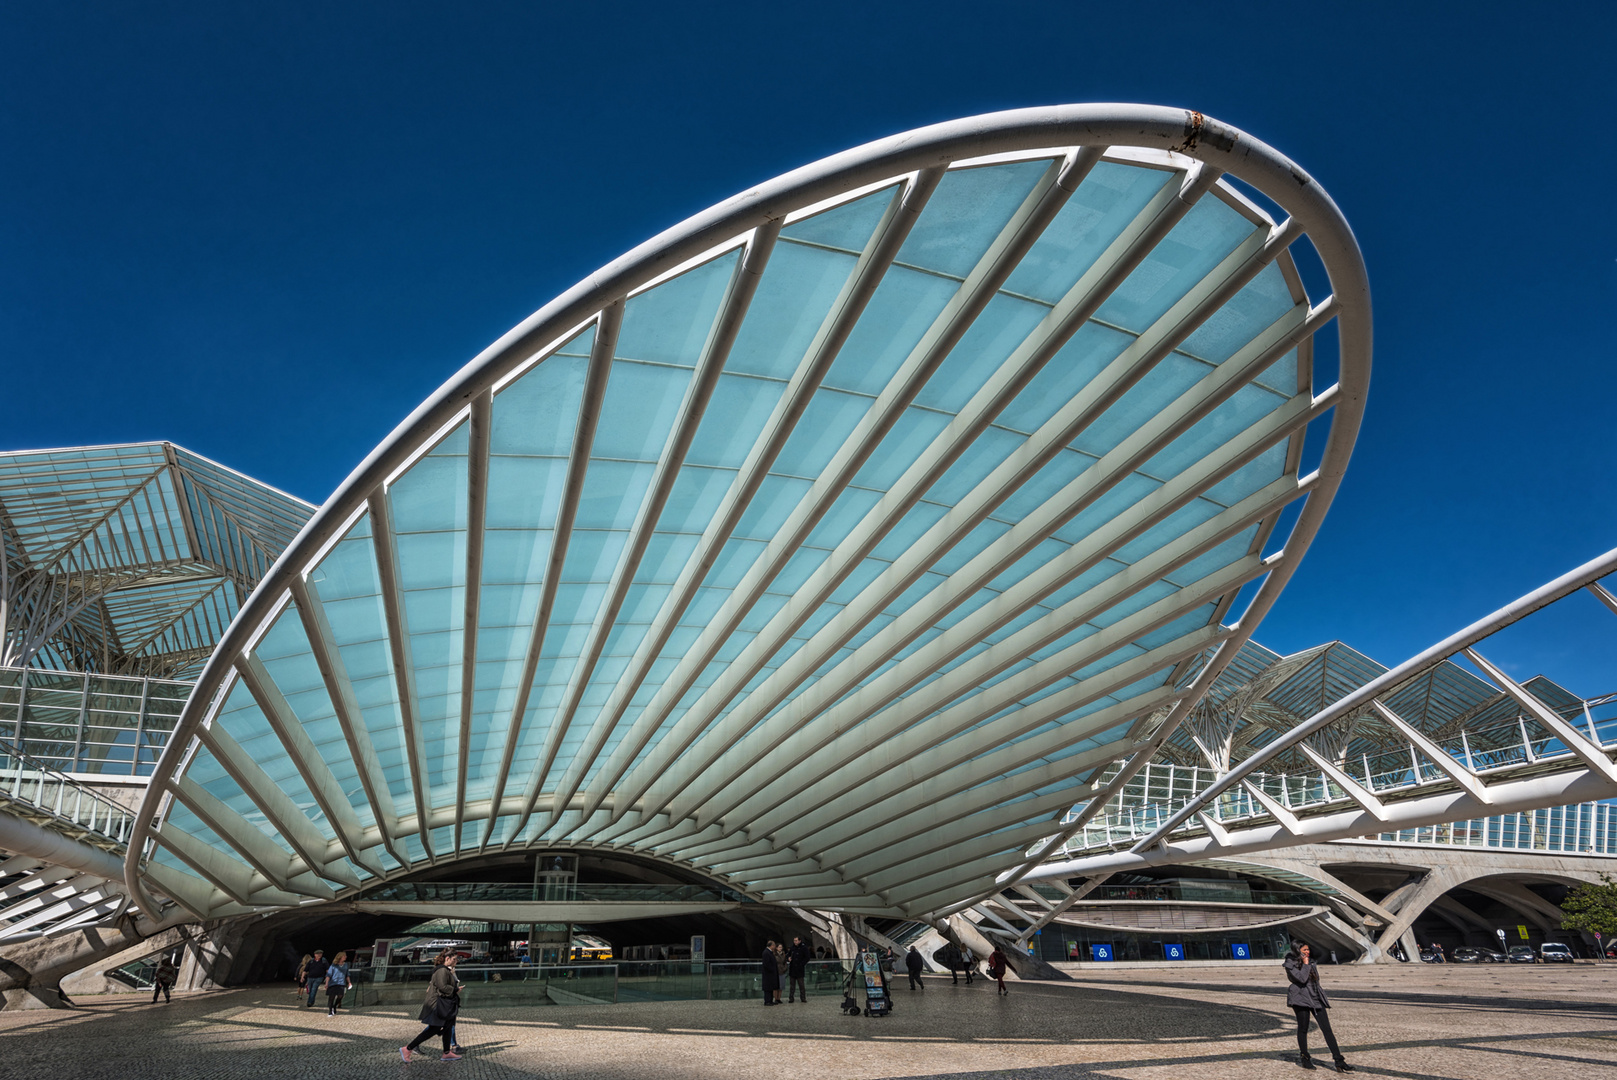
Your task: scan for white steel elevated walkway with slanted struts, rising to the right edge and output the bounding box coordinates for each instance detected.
[1007,551,1617,880]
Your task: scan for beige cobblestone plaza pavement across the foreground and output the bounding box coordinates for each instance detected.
[0,964,1617,1080]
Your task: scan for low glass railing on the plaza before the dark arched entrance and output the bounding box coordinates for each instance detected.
[351,960,852,1009]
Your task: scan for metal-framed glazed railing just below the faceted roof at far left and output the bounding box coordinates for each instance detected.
[0,668,192,776]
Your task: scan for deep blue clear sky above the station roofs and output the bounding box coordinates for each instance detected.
[0,0,1617,692]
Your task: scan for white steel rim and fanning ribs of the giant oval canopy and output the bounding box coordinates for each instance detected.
[125,105,1371,913]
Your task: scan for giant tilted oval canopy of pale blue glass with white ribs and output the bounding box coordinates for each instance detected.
[126,105,1370,915]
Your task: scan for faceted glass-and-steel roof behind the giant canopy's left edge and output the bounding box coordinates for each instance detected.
[0,443,314,679]
